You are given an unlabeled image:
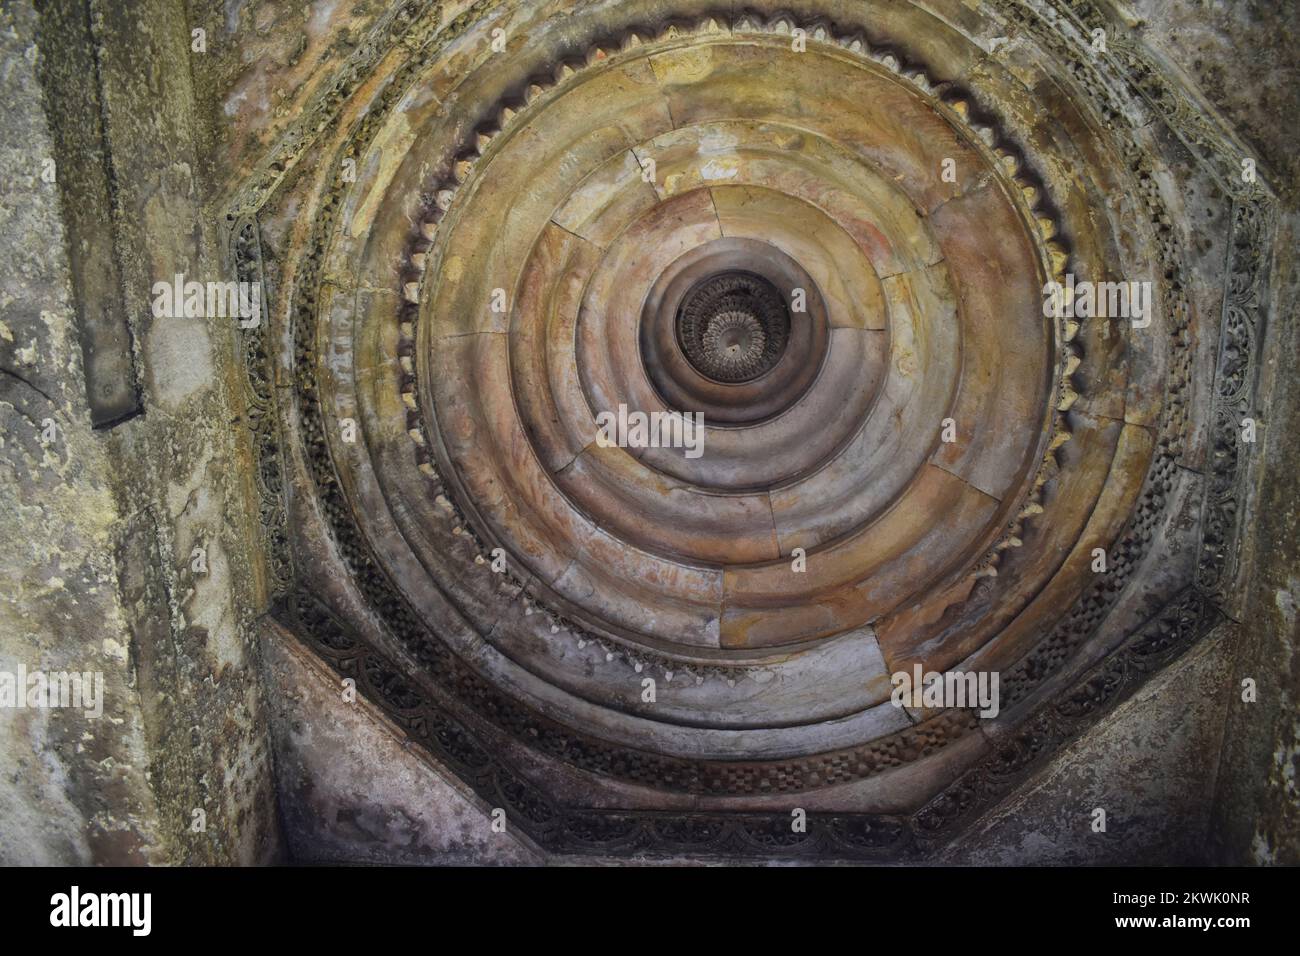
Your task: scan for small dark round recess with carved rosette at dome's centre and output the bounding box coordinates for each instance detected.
[676,269,790,385]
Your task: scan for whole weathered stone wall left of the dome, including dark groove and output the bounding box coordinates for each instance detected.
[0,3,278,864]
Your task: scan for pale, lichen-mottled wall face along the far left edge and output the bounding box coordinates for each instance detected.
[0,4,166,866]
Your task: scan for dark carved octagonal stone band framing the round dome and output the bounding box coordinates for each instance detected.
[229,0,1274,860]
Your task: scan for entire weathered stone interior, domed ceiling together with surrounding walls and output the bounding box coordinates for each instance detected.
[0,0,1300,864]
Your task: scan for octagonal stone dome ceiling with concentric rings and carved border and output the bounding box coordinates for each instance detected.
[220,0,1270,860]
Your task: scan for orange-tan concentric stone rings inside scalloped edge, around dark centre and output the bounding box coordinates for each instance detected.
[424,37,1058,649]
